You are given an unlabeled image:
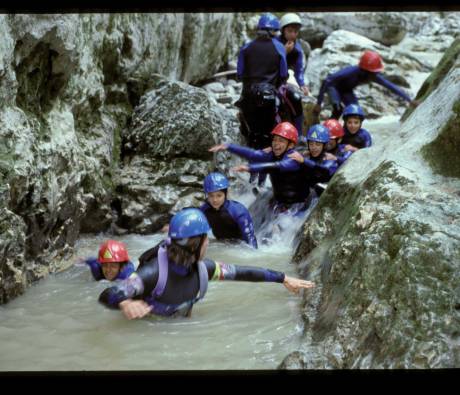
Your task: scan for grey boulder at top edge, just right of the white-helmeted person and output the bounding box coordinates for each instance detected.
[300,12,406,48]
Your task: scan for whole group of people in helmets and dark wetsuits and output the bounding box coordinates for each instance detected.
[86,13,418,319]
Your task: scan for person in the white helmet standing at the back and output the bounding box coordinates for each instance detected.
[277,13,309,137]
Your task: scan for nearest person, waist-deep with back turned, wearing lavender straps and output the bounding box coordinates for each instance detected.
[99,208,314,319]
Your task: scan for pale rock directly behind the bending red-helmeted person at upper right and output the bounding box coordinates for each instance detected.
[306,30,431,118]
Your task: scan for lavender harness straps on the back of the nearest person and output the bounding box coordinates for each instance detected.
[148,240,208,316]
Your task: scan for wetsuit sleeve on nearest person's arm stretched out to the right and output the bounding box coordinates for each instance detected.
[204,259,285,283]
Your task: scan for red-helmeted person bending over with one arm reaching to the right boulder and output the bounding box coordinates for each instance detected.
[315,51,419,119]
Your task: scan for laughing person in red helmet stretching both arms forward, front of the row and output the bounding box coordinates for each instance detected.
[209,122,310,217]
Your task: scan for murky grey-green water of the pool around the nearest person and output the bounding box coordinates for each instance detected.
[0,235,310,371]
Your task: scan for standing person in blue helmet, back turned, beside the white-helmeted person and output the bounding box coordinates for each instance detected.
[235,13,289,185]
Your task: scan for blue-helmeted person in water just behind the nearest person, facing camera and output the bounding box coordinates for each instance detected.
[200,172,257,248]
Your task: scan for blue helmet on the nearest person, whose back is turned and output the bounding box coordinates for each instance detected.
[168,208,211,239]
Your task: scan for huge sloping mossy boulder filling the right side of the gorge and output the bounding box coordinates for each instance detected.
[281,38,460,369]
